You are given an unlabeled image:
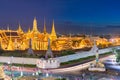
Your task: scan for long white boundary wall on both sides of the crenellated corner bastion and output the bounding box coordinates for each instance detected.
[0,47,118,65]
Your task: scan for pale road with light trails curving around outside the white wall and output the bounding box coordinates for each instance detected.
[4,55,115,73]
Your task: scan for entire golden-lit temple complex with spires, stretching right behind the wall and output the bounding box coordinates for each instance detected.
[0,18,118,51]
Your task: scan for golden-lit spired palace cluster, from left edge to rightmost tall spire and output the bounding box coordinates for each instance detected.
[0,18,57,51]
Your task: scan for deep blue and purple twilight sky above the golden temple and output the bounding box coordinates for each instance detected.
[0,0,120,33]
